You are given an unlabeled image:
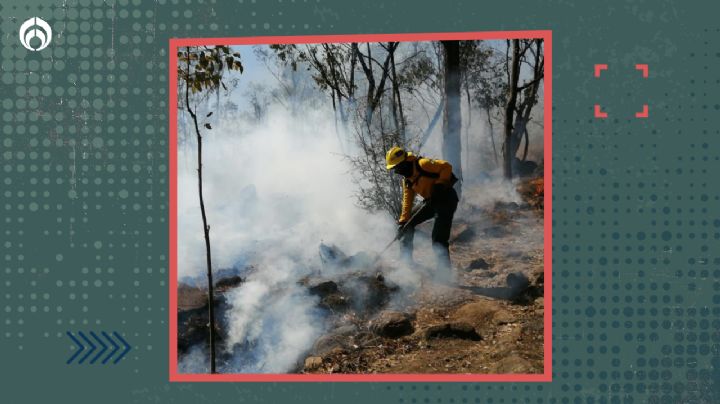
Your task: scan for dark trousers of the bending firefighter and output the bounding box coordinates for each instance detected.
[401,188,458,269]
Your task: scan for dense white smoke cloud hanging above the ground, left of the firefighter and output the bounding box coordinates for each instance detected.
[178,104,393,278]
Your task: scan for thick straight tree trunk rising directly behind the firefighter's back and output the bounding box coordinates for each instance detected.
[442,41,462,178]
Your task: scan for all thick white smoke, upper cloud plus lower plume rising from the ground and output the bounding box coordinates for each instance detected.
[178,103,394,373]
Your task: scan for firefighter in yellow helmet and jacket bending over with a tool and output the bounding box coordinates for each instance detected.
[385,147,458,270]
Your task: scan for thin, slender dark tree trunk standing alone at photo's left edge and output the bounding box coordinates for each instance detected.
[185,48,217,373]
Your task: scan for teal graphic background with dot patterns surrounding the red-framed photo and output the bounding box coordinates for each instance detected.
[0,0,720,403]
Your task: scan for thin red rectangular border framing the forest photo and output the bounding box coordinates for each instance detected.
[168,30,552,382]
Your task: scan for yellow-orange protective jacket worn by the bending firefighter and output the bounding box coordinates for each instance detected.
[399,155,452,223]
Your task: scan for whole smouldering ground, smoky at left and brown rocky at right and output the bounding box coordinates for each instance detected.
[178,179,544,373]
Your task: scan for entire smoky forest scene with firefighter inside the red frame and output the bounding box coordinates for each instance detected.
[177,39,545,374]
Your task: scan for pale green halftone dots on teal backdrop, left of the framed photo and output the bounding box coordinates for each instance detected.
[3,2,167,372]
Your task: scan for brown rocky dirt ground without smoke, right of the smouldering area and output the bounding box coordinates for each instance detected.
[302,181,544,374]
